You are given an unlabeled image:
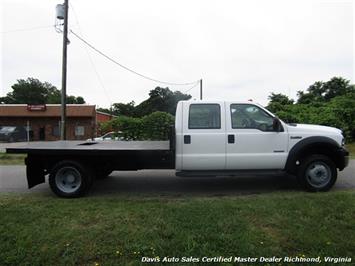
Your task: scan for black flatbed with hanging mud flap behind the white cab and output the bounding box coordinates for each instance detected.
[6,141,175,194]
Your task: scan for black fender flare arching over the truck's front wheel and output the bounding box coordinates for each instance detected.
[285,136,342,173]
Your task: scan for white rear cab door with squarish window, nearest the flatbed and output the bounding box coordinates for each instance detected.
[181,102,226,171]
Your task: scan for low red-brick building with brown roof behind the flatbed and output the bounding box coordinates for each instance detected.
[0,104,96,140]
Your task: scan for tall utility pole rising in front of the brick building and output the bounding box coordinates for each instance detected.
[60,0,69,140]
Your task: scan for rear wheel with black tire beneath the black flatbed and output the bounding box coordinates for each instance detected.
[49,160,93,198]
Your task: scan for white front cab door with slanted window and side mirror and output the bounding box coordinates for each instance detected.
[226,103,288,170]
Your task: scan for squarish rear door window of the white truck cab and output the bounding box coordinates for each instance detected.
[189,104,221,129]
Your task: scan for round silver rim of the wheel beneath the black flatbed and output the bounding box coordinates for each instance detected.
[55,166,81,193]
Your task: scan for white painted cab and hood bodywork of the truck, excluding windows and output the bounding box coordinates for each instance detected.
[175,101,343,171]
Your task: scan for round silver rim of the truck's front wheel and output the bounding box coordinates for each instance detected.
[306,161,332,188]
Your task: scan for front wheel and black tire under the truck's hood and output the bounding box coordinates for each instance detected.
[297,154,337,192]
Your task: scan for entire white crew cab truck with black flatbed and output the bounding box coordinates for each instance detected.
[7,101,349,197]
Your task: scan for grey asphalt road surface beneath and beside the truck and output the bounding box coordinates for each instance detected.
[0,160,355,196]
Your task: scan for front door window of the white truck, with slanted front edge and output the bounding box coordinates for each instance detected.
[231,104,273,131]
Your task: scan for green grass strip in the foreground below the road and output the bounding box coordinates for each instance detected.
[0,191,355,265]
